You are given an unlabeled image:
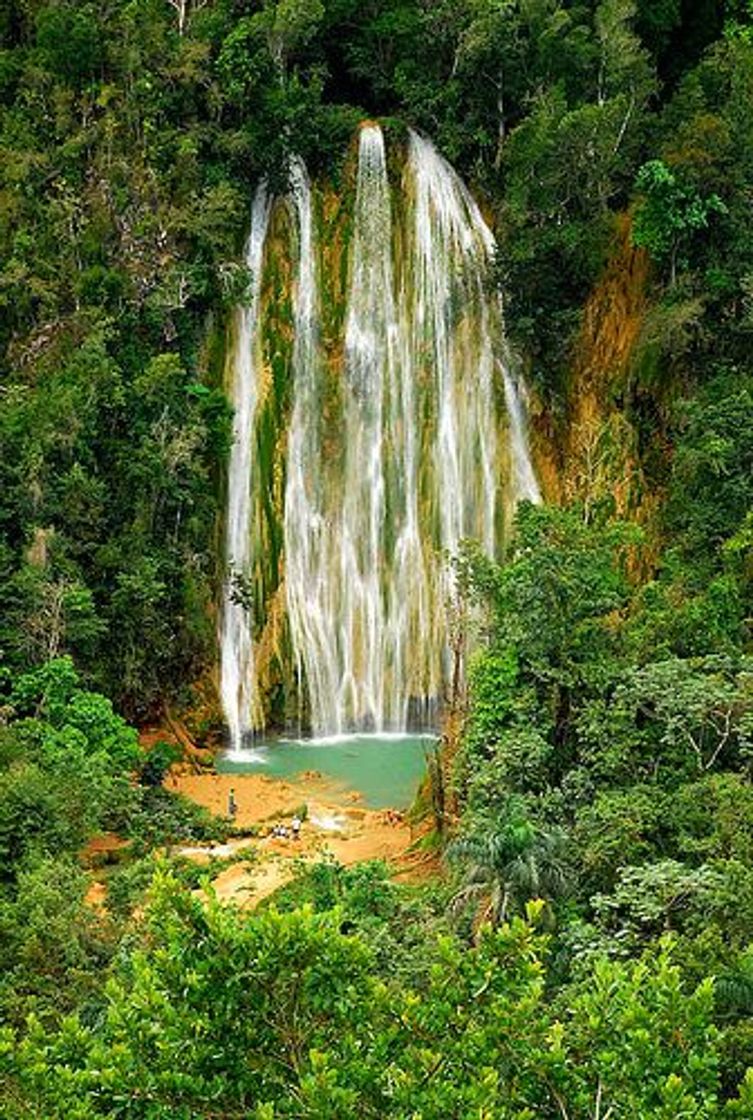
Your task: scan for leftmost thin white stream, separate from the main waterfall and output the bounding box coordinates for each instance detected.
[220,183,270,752]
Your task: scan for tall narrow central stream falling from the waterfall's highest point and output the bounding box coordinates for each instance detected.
[336,127,398,731]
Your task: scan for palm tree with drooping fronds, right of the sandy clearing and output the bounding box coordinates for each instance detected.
[447,816,570,926]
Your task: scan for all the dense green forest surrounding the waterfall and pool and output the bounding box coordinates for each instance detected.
[0,0,753,1120]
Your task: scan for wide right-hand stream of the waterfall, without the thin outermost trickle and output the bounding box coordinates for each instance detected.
[403,132,499,554]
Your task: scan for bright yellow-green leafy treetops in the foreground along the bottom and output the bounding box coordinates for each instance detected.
[5,880,753,1120]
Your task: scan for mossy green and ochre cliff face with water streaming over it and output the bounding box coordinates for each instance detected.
[220,123,538,740]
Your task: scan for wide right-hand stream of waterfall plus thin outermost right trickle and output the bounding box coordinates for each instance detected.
[407,132,540,521]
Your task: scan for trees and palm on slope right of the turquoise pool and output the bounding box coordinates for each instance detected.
[449,495,753,1084]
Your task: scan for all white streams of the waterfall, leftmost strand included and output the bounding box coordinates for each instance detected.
[217,124,539,743]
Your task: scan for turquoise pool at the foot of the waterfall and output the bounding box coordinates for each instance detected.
[216,735,437,809]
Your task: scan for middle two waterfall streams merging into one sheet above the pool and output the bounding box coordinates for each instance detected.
[285,127,428,734]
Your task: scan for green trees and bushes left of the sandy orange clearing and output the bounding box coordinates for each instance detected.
[0,657,223,1039]
